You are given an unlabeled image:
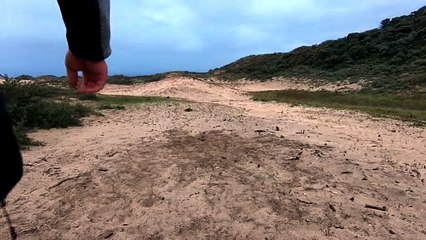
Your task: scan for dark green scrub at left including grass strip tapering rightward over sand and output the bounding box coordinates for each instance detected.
[0,76,172,147]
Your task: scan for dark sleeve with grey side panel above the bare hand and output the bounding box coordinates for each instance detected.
[58,0,111,61]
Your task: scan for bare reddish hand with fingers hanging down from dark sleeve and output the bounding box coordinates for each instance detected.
[65,51,108,94]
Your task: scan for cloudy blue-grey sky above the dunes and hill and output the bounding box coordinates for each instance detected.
[0,0,426,76]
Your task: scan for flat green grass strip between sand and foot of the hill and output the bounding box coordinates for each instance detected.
[252,90,426,126]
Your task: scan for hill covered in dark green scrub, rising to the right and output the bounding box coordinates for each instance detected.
[209,6,426,92]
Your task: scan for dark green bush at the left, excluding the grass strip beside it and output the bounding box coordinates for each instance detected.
[0,81,92,145]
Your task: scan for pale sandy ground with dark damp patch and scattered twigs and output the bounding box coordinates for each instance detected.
[0,78,426,240]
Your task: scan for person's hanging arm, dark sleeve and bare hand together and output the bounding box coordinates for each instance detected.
[58,0,111,93]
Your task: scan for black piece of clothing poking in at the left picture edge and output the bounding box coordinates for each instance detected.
[0,94,23,202]
